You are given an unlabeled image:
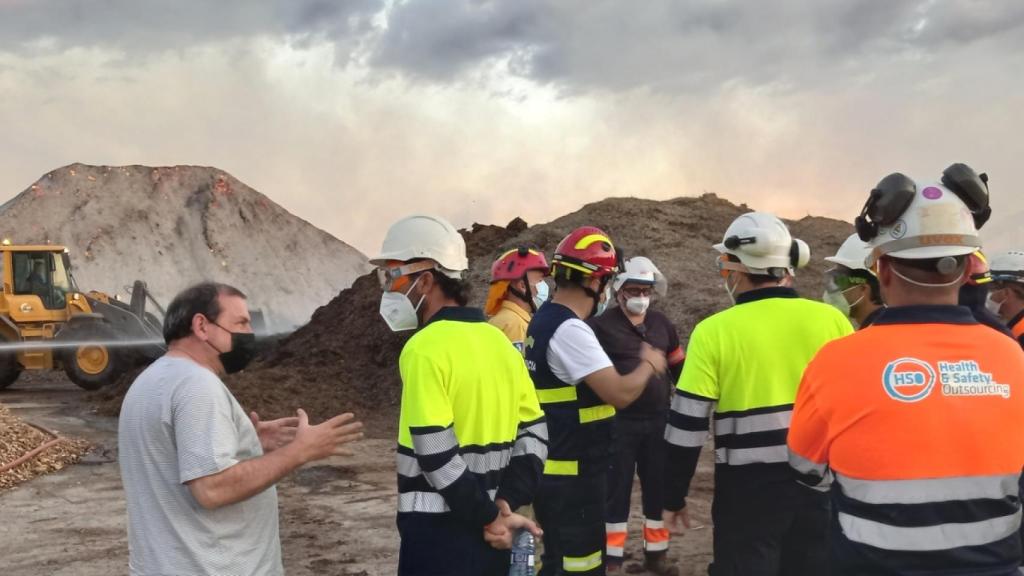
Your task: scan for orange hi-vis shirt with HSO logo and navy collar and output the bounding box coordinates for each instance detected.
[788,306,1024,576]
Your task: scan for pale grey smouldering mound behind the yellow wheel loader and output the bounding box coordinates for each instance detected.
[0,164,370,332]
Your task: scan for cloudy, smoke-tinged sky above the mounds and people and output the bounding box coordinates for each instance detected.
[0,0,1024,252]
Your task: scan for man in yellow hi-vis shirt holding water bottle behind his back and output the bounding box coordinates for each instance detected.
[370,215,548,576]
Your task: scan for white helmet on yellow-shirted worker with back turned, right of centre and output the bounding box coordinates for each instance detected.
[715,212,811,274]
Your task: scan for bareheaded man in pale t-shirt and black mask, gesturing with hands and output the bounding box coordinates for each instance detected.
[118,283,361,576]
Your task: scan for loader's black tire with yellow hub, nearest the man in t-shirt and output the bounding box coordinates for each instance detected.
[58,322,126,390]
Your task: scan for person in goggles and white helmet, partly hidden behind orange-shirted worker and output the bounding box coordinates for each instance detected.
[821,234,886,330]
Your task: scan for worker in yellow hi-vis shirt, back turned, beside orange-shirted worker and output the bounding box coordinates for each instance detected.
[664,212,853,576]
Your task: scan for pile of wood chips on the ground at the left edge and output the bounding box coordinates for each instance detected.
[0,404,89,490]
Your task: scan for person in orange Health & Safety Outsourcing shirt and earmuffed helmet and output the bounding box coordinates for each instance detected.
[787,164,1024,576]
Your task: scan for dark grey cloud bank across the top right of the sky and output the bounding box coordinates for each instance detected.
[370,0,1024,91]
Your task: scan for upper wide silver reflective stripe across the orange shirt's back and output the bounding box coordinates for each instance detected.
[836,474,1020,504]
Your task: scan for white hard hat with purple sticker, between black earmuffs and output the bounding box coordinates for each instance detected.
[864,182,981,268]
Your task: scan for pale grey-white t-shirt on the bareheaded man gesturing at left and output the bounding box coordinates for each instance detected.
[118,356,284,576]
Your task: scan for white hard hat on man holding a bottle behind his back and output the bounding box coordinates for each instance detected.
[370,215,469,278]
